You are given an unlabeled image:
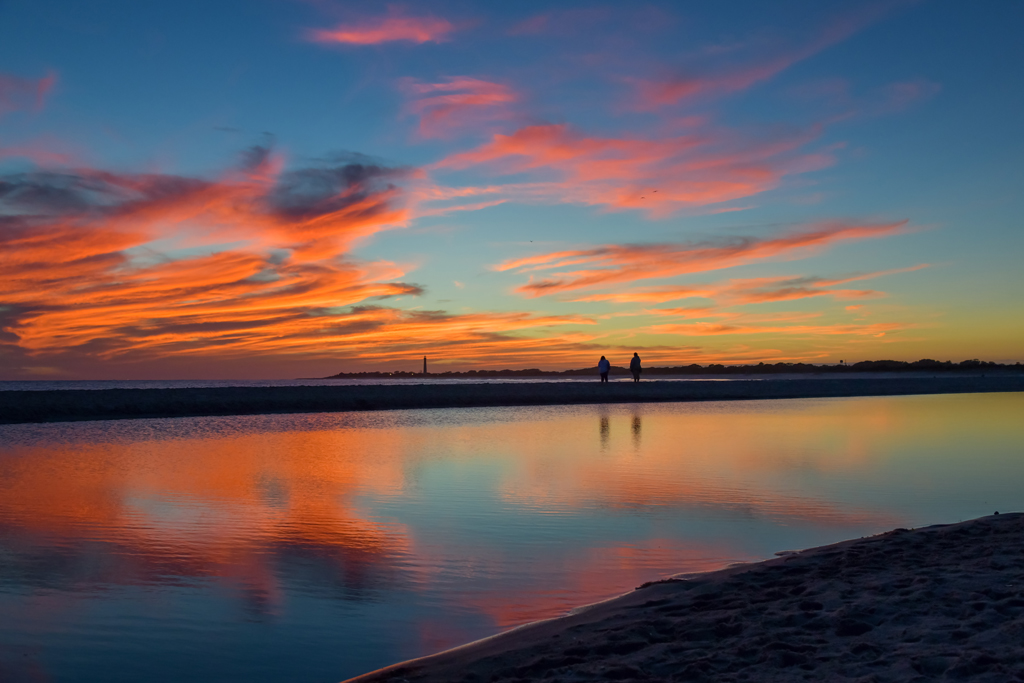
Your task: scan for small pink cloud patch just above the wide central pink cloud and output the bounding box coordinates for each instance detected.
[403,76,518,137]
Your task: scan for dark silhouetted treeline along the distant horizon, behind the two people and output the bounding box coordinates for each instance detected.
[324,358,1024,380]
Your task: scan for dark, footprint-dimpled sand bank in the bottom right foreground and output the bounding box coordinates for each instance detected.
[351,513,1024,683]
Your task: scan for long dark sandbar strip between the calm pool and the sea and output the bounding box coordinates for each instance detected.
[0,375,1024,424]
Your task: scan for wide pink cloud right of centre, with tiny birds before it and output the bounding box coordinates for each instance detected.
[433,124,833,216]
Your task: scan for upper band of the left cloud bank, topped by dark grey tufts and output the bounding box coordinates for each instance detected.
[0,147,409,257]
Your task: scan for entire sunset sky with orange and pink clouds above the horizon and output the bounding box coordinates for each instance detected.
[0,0,1024,380]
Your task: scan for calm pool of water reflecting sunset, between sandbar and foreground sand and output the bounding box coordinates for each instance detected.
[0,393,1024,683]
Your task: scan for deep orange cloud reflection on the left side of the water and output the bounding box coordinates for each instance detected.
[0,423,409,596]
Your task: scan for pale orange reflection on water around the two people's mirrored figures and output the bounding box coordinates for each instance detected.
[483,407,892,525]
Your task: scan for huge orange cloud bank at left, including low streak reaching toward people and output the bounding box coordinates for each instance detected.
[0,148,634,372]
